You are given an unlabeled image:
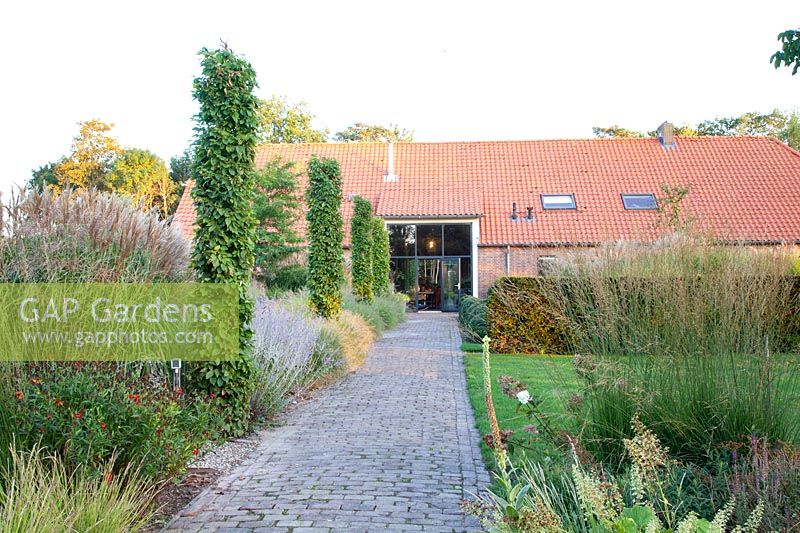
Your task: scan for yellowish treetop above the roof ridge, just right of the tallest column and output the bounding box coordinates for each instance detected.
[258,95,328,143]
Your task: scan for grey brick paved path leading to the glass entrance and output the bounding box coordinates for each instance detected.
[166,313,489,533]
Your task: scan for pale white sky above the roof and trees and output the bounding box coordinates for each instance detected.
[0,0,800,200]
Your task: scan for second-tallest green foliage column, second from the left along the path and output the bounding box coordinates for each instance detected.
[306,156,344,318]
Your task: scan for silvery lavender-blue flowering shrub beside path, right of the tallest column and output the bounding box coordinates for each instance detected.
[251,298,321,419]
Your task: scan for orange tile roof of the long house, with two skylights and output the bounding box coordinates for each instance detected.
[175,137,800,245]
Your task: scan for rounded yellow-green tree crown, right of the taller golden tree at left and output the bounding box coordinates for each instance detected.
[108,148,176,218]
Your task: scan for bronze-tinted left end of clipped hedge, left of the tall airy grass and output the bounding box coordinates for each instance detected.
[487,277,567,354]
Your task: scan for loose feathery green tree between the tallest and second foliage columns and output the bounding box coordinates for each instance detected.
[253,159,303,287]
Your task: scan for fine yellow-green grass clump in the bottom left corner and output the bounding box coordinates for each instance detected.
[0,446,155,533]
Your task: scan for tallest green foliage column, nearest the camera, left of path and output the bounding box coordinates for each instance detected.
[189,47,258,435]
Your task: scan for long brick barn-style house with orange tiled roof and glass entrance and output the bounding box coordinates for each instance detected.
[175,123,800,311]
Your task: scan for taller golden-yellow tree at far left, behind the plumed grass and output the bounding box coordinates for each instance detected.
[55,119,122,190]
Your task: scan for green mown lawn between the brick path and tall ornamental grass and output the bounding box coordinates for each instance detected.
[464,353,578,467]
